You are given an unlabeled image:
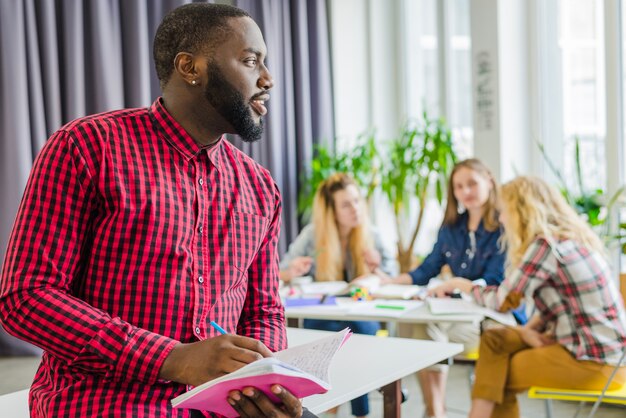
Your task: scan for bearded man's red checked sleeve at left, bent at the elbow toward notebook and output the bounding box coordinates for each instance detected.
[0,131,177,383]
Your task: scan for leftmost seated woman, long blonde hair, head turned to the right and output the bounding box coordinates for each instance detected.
[280,173,395,417]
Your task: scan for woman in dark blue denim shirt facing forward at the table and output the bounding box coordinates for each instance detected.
[391,158,505,417]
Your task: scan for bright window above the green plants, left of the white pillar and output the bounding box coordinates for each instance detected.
[404,0,473,158]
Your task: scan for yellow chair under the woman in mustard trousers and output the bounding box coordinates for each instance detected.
[528,348,626,418]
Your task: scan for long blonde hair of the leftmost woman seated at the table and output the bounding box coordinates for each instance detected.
[313,173,372,281]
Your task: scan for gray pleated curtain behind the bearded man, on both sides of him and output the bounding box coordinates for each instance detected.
[0,0,334,355]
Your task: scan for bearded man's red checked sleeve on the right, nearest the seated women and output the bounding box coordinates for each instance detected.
[237,186,287,351]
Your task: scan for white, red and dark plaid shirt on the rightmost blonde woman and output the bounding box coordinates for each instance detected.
[473,238,626,364]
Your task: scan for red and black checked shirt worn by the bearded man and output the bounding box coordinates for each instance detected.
[0,99,286,418]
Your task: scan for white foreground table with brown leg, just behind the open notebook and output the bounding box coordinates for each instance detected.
[287,328,463,418]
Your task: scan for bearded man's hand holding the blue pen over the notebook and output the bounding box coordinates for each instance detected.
[159,334,272,386]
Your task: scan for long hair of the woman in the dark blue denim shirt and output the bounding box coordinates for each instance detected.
[442,158,500,232]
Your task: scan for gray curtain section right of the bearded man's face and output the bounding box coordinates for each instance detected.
[233,0,334,254]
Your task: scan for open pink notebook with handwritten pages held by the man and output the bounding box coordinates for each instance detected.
[172,328,352,417]
